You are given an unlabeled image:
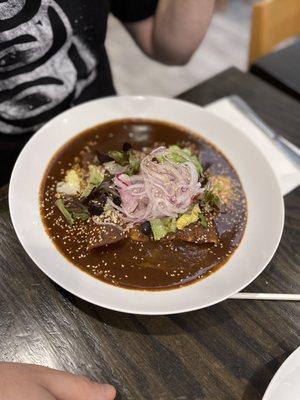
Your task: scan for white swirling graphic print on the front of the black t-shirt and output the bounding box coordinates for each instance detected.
[0,0,97,134]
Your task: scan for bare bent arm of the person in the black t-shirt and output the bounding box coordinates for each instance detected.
[124,0,214,65]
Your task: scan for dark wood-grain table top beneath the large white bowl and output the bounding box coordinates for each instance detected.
[0,68,300,400]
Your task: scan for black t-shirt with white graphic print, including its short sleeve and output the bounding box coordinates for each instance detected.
[0,0,158,136]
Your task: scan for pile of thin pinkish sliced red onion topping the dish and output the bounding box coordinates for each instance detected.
[114,147,203,223]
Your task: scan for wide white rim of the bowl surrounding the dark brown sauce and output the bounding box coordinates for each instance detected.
[9,96,284,314]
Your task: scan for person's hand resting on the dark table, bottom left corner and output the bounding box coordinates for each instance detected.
[0,363,116,400]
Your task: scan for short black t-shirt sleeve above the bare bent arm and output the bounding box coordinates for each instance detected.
[110,0,158,22]
